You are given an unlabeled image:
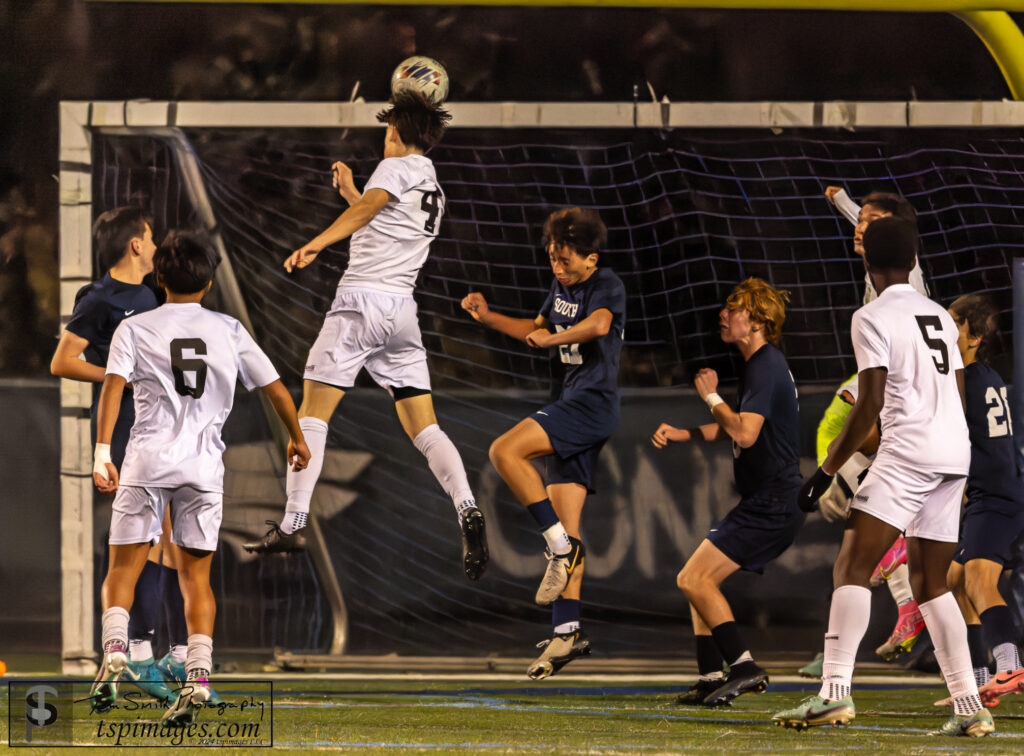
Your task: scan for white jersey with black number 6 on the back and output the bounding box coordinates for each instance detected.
[106,303,278,493]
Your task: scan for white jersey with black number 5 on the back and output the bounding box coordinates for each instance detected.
[851,284,971,475]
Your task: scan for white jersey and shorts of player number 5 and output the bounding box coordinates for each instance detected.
[851,284,971,543]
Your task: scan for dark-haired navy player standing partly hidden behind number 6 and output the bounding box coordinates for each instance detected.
[50,207,185,701]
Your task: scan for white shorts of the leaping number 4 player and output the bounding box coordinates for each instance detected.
[303,287,430,391]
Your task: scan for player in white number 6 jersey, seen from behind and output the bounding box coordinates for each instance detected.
[91,234,309,724]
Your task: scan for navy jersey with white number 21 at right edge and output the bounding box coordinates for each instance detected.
[964,362,1024,508]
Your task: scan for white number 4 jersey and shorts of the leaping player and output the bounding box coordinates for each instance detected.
[304,155,445,390]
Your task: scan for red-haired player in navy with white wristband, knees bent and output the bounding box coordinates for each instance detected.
[651,279,805,706]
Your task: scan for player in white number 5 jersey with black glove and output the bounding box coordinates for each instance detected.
[772,218,994,738]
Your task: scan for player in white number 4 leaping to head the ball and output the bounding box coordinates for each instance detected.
[246,91,488,580]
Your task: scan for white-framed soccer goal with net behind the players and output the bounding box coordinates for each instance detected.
[61,102,1024,658]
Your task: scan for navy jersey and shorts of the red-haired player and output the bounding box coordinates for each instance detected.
[708,344,806,572]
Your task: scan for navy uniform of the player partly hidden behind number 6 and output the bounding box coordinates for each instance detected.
[67,274,157,469]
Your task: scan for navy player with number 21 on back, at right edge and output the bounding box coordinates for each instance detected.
[941,294,1024,708]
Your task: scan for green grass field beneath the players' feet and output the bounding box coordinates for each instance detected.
[6,675,1024,754]
